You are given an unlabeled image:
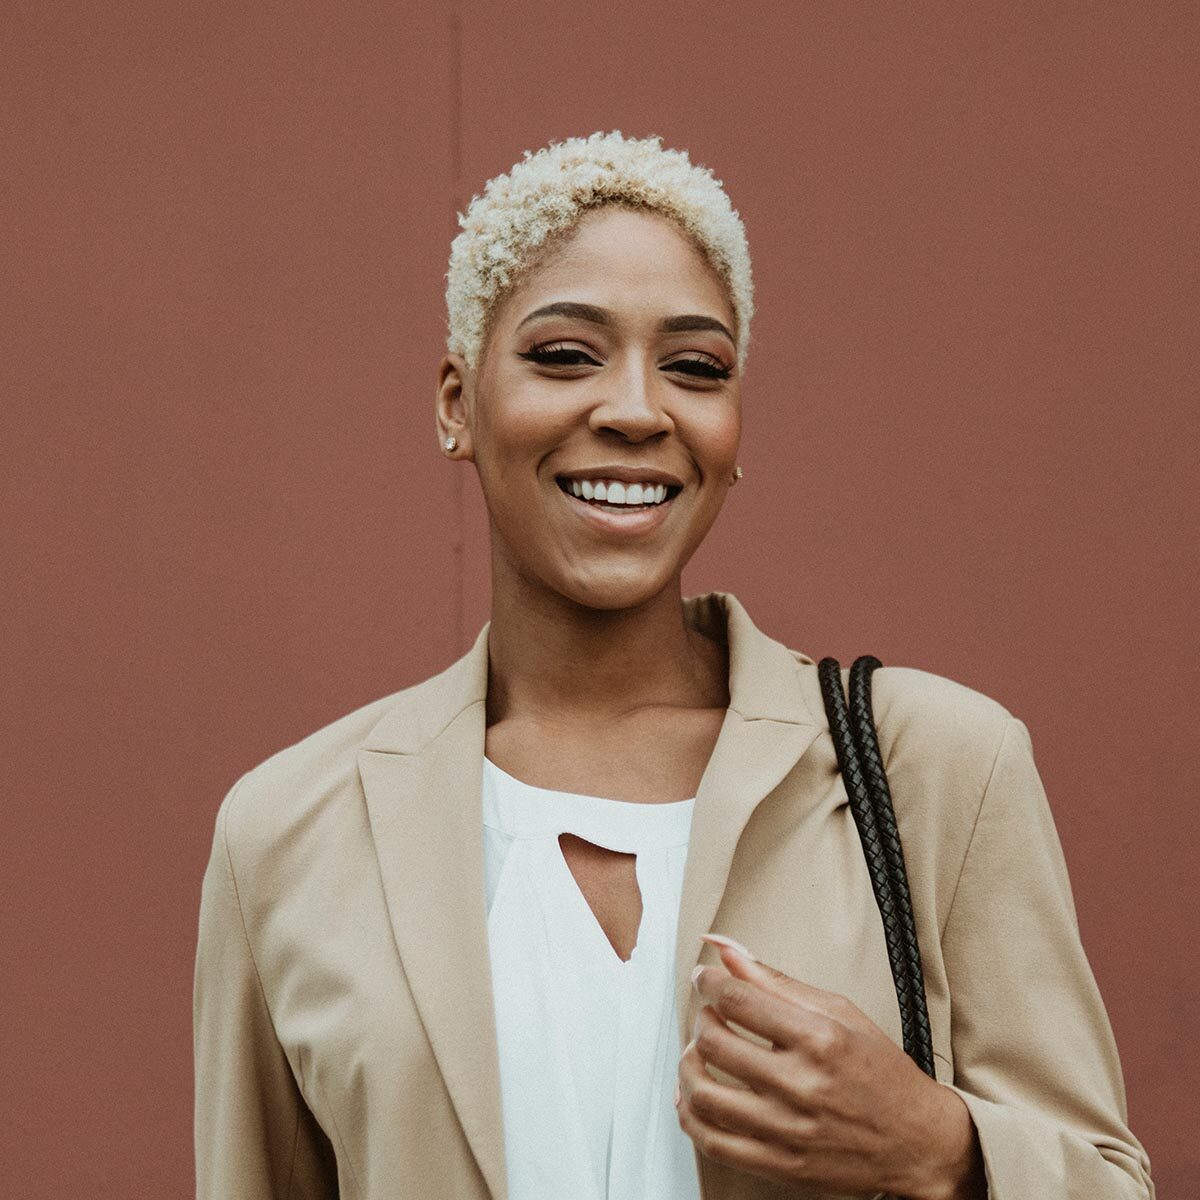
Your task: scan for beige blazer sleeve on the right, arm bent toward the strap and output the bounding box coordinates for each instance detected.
[942,715,1154,1200]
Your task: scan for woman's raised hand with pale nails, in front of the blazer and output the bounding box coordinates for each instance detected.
[678,946,978,1198]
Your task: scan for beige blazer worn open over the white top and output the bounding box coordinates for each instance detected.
[194,592,1154,1200]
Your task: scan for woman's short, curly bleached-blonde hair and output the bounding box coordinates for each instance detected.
[446,130,754,368]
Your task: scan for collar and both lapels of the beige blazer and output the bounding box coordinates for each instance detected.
[358,592,823,1200]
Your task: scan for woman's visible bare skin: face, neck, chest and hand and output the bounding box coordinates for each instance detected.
[436,205,985,1200]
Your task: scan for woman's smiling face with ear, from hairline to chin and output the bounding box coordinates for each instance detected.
[437,205,742,608]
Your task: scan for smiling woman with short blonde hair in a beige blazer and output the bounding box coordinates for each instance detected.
[194,132,1154,1200]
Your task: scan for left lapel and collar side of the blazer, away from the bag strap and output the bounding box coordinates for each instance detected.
[358,622,508,1200]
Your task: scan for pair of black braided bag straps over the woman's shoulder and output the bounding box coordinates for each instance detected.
[817,654,935,1075]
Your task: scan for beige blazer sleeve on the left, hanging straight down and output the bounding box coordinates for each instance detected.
[192,776,338,1200]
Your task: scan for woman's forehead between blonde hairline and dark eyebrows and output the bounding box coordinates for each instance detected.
[496,204,733,326]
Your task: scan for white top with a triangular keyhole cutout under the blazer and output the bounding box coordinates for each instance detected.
[484,756,700,1200]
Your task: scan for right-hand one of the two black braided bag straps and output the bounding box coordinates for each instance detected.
[850,654,935,1075]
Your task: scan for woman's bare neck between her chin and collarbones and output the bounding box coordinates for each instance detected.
[487,575,728,726]
